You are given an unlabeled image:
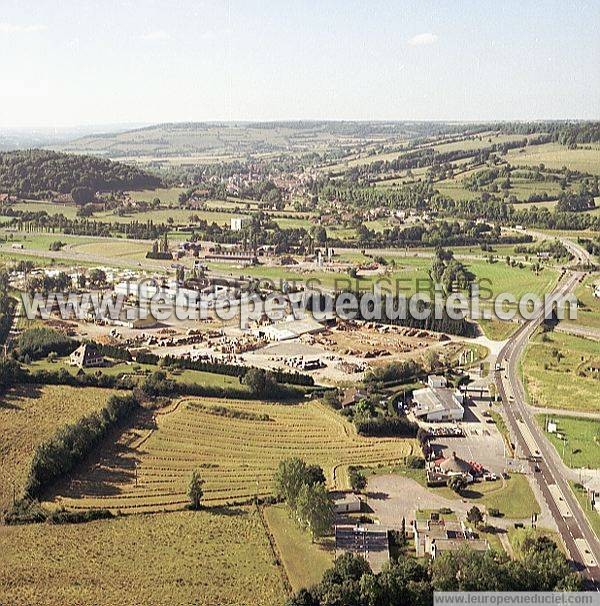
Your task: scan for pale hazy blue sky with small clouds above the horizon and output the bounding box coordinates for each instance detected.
[0,0,600,127]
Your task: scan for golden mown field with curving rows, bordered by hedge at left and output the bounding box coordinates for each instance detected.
[55,398,418,512]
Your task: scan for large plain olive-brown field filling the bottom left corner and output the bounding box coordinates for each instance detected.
[0,508,285,606]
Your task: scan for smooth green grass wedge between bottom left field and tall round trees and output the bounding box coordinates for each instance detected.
[264,504,335,591]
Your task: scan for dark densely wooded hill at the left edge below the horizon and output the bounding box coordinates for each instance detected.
[0,149,161,197]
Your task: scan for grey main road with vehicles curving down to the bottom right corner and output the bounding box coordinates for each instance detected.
[495,240,600,589]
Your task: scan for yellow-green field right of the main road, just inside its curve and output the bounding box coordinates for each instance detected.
[522,332,600,412]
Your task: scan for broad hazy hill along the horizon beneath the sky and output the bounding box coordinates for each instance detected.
[55,121,464,158]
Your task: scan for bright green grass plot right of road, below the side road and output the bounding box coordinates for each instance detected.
[536,415,600,469]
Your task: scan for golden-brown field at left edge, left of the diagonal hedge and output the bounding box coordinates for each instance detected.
[0,385,118,511]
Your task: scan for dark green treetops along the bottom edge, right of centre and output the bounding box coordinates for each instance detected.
[286,536,582,606]
